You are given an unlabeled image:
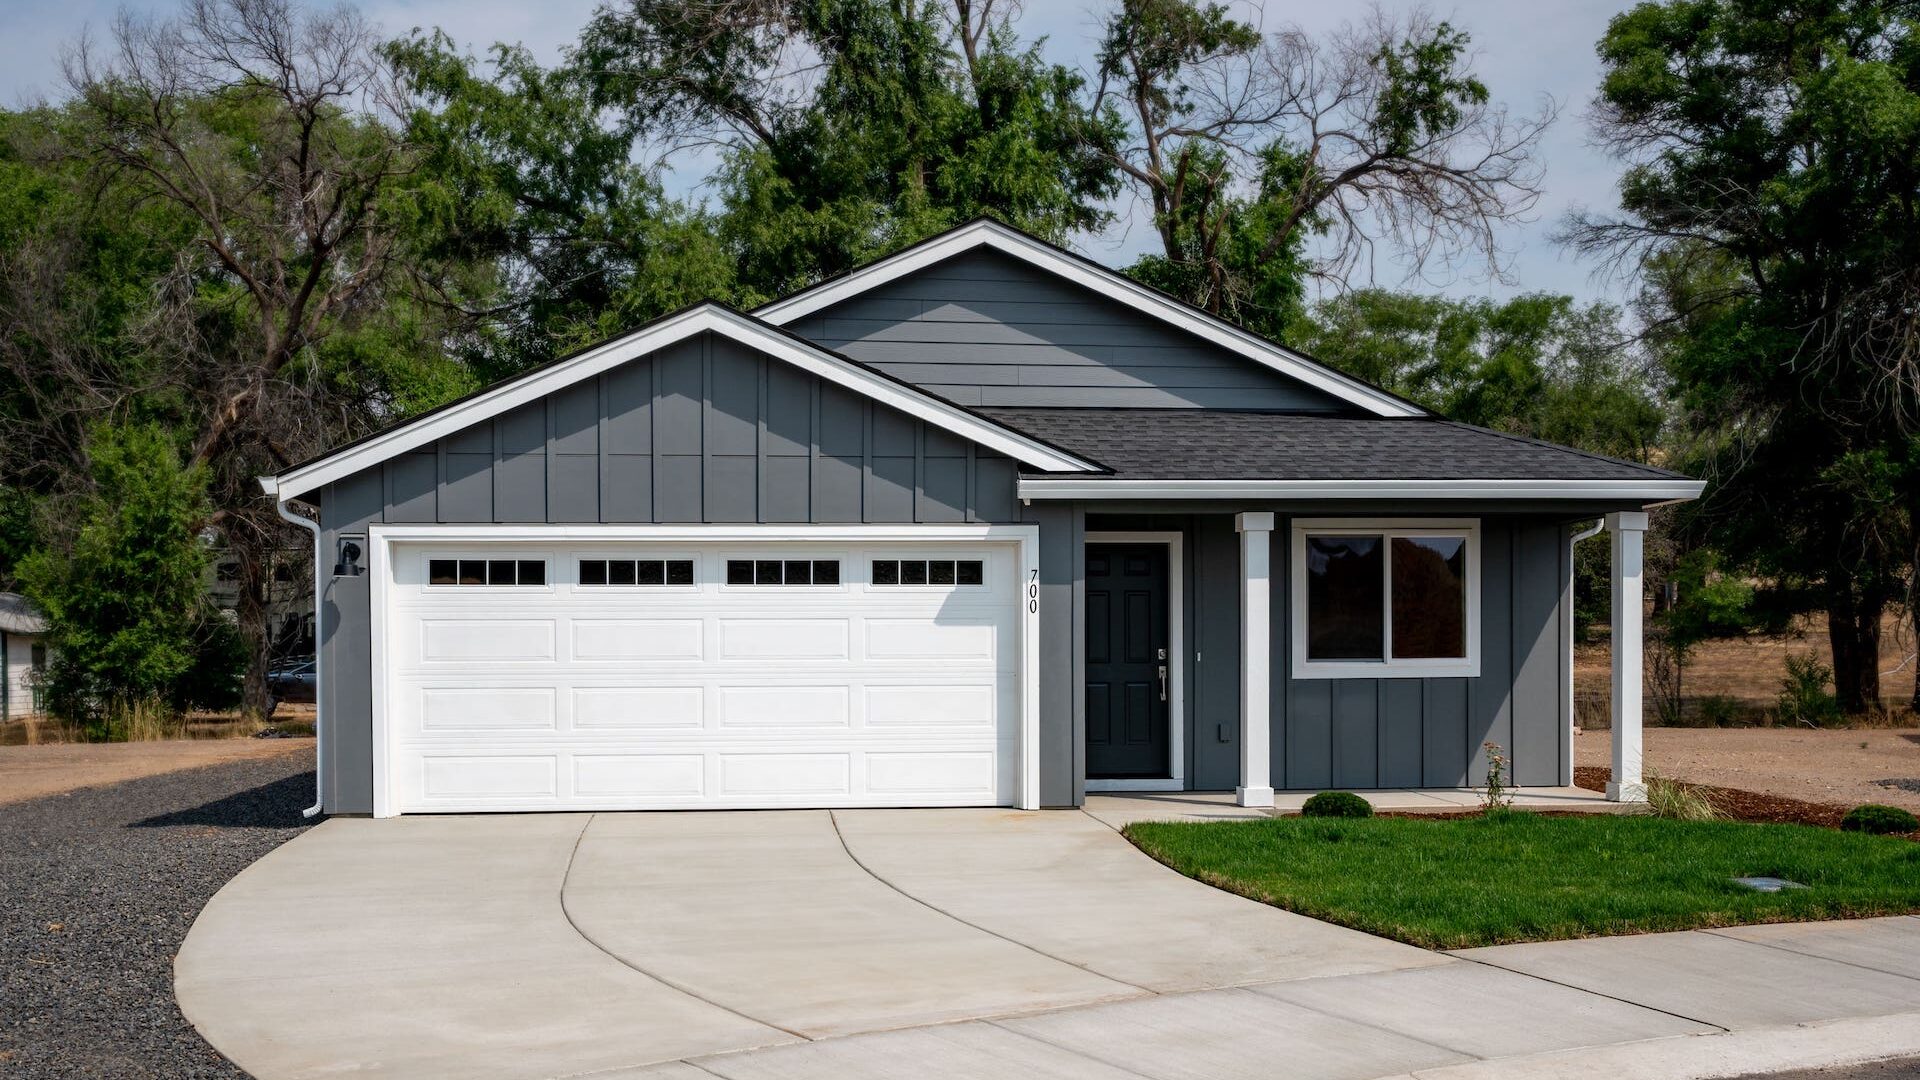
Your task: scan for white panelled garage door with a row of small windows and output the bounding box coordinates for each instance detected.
[382,540,1023,813]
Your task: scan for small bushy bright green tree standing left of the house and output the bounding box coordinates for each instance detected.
[17,425,221,734]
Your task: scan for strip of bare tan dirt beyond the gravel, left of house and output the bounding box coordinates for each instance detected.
[0,738,313,805]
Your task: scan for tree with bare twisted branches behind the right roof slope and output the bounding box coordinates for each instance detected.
[1089,0,1553,336]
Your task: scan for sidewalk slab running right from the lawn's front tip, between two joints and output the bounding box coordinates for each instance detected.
[1455,930,1920,1028]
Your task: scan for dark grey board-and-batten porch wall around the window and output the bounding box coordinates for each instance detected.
[1144,515,1572,792]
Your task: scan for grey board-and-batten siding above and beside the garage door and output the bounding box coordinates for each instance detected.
[319,334,1036,813]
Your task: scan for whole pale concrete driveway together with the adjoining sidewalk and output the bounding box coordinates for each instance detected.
[177,803,1920,1080]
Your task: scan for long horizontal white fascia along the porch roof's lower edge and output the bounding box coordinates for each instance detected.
[1020,479,1707,502]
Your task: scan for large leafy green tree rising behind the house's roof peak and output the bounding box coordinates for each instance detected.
[574,0,1117,300]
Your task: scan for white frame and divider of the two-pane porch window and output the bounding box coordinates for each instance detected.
[1288,517,1480,678]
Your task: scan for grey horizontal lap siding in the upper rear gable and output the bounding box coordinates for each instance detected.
[789,248,1344,411]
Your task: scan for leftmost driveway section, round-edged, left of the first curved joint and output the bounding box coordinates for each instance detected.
[175,815,795,1080]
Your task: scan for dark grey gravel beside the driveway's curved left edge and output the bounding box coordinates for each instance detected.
[0,749,313,1080]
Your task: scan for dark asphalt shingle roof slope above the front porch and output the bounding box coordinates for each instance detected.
[975,407,1680,480]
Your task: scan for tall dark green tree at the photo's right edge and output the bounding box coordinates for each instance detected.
[1569,0,1920,713]
